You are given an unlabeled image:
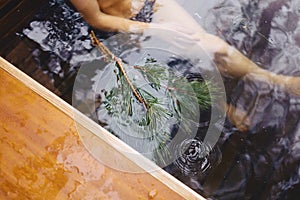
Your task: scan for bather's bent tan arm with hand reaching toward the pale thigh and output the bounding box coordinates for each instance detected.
[71,0,148,32]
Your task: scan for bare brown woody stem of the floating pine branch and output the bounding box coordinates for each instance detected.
[90,31,148,107]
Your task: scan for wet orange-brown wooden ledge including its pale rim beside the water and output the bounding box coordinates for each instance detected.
[0,57,204,199]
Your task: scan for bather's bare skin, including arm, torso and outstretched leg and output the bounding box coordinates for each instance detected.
[71,0,300,130]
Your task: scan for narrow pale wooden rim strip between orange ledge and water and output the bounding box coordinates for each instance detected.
[0,56,205,200]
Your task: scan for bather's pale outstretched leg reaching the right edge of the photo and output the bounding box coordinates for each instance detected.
[153,0,300,95]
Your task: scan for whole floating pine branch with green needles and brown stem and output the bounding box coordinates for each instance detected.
[91,32,218,165]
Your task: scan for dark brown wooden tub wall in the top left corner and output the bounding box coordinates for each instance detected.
[0,0,72,99]
